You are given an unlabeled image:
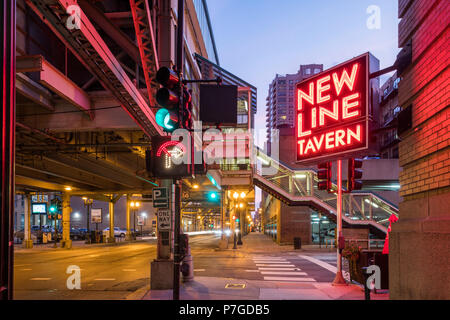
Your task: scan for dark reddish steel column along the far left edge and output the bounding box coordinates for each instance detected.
[0,0,16,300]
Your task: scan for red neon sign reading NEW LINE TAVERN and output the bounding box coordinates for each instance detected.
[295,53,369,161]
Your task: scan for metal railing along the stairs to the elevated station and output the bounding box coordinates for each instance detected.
[254,149,398,230]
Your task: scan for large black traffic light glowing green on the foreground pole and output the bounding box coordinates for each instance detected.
[155,67,181,132]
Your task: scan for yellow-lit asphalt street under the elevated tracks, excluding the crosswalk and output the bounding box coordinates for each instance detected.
[14,235,218,300]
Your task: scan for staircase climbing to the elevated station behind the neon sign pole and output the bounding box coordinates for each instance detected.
[253,148,398,236]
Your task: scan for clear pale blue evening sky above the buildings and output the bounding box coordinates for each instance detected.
[207,0,399,136]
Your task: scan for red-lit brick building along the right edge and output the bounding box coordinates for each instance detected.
[389,0,450,299]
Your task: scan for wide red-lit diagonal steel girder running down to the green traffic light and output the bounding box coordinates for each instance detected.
[26,0,166,136]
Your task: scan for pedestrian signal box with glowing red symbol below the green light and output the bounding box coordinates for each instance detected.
[145,136,191,179]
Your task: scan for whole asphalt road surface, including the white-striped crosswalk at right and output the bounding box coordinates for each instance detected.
[14,235,335,300]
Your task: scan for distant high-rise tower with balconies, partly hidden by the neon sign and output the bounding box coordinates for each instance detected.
[266,64,323,152]
